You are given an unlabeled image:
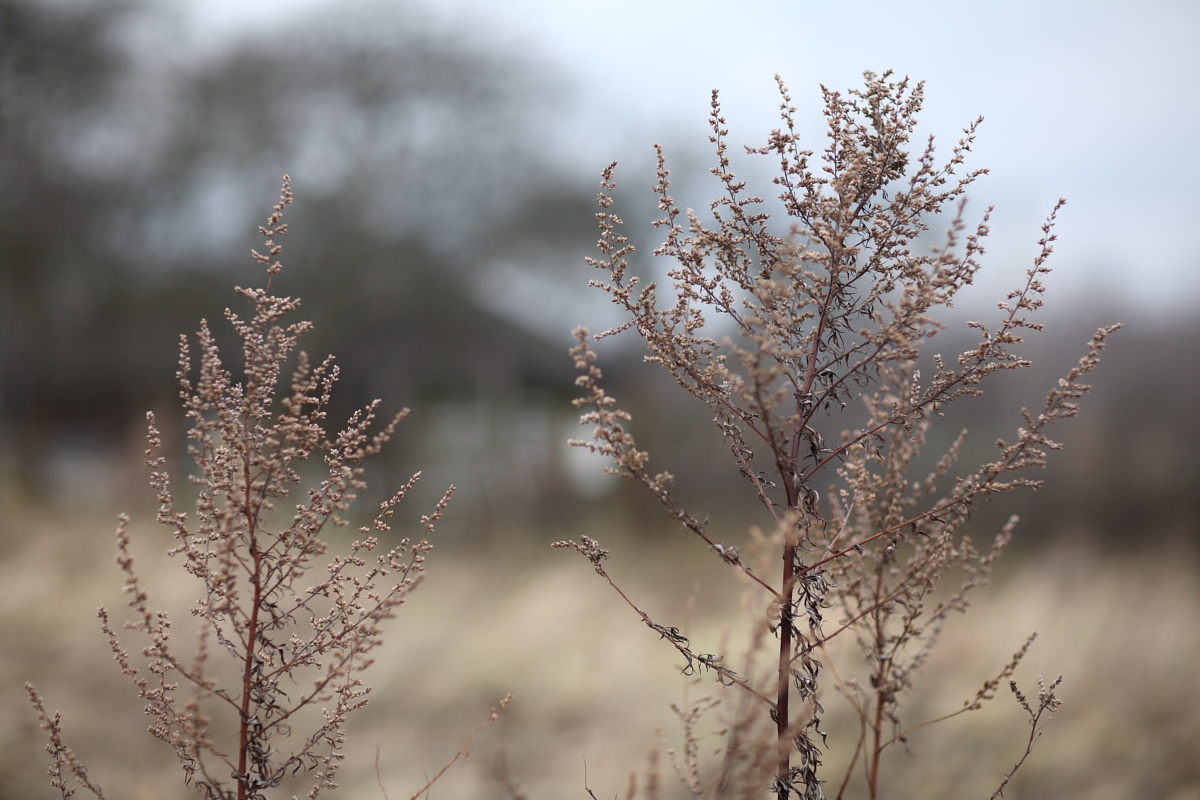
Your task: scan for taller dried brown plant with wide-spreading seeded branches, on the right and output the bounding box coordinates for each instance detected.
[556,72,1117,800]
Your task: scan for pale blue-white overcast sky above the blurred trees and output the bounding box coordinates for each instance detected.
[193,0,1200,314]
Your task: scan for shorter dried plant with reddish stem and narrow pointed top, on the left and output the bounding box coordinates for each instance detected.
[28,178,472,800]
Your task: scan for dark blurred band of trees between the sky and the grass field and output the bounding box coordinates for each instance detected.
[0,0,1200,551]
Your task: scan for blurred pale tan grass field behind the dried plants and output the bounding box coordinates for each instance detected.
[0,513,1200,800]
